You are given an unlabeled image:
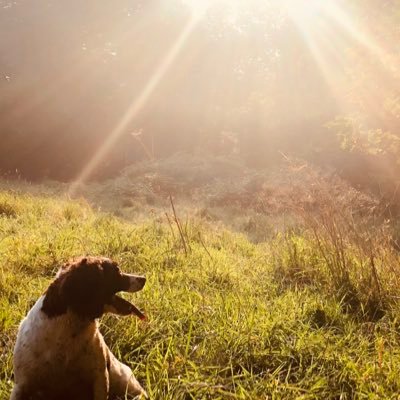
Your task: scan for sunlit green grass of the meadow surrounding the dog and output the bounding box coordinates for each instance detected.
[0,191,400,400]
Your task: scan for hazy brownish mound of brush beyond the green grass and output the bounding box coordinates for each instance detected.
[85,153,373,209]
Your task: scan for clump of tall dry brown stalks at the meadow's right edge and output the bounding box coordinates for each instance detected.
[275,170,400,320]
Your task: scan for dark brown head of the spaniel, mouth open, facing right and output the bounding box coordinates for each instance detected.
[42,257,146,319]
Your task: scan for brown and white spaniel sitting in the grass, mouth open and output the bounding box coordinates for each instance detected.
[11,257,147,400]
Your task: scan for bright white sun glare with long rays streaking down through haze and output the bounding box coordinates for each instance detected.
[67,0,392,193]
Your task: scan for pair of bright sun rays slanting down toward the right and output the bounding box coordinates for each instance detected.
[285,0,395,114]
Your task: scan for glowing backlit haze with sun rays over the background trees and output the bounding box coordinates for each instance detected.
[0,0,399,185]
